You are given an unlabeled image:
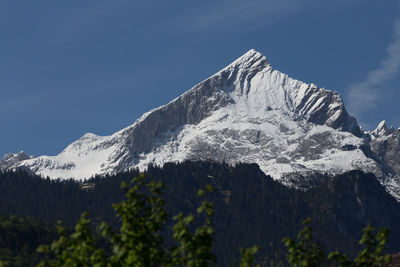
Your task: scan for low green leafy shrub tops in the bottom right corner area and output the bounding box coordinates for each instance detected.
[283,218,390,267]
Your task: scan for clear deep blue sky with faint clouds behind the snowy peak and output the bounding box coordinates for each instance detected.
[0,0,400,157]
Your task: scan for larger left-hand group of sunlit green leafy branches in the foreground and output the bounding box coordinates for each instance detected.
[38,175,248,267]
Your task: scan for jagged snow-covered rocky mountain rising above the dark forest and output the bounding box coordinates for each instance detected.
[0,50,400,199]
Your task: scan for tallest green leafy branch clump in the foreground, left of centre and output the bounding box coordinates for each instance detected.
[100,174,167,266]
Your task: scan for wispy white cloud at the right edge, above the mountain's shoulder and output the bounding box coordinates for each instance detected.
[348,18,400,116]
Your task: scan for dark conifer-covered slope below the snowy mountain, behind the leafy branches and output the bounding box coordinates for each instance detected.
[0,162,400,266]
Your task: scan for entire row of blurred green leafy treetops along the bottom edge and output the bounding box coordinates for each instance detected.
[33,175,389,267]
